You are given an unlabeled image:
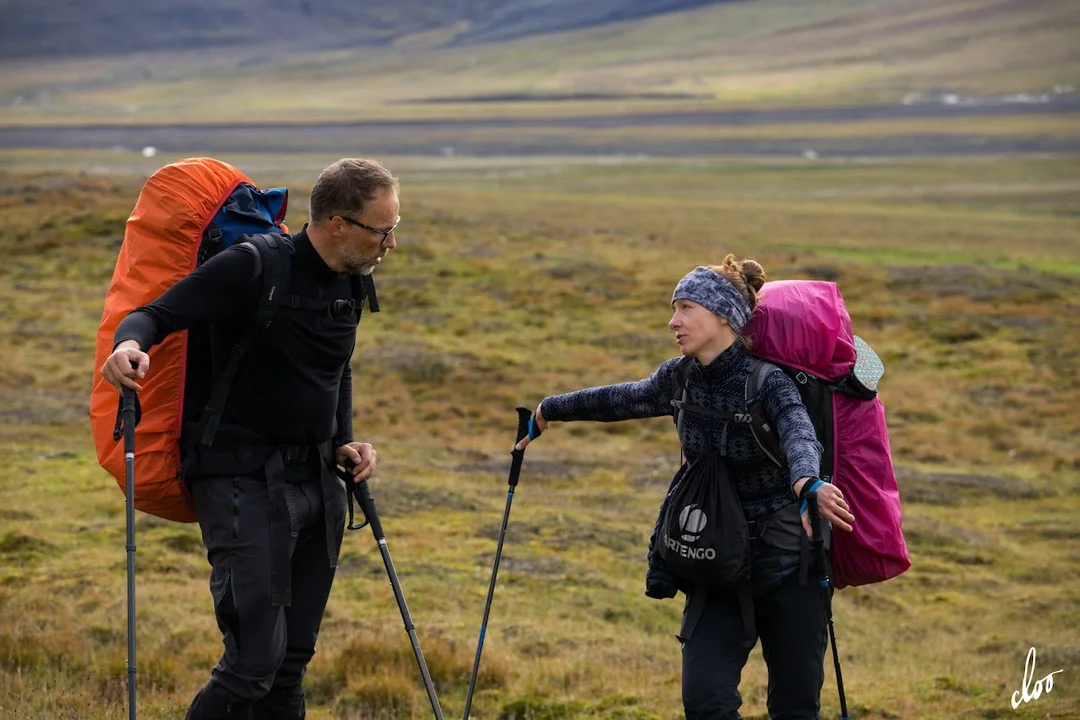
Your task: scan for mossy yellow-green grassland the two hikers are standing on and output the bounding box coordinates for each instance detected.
[0,148,1080,720]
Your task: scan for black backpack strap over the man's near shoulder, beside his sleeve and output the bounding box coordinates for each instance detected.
[193,233,293,447]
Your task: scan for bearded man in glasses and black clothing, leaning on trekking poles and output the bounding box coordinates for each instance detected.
[102,159,400,720]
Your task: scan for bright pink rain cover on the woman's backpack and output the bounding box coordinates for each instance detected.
[747,281,912,589]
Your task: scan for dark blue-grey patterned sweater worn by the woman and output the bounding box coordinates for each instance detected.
[541,343,822,520]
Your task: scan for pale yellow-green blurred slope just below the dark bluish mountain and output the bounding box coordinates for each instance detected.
[0,0,1080,124]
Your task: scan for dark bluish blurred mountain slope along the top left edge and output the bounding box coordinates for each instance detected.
[0,0,730,59]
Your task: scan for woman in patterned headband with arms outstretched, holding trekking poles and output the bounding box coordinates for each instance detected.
[517,255,854,720]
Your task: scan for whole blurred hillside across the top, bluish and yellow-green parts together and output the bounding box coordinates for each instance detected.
[0,0,1080,125]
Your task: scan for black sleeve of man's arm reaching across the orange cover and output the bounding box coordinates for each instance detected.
[112,246,261,352]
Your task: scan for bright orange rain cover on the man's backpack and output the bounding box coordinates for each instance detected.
[90,158,266,522]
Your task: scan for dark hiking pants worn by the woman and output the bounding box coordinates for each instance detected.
[683,554,827,720]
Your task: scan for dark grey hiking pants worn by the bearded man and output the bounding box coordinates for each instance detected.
[180,452,346,720]
